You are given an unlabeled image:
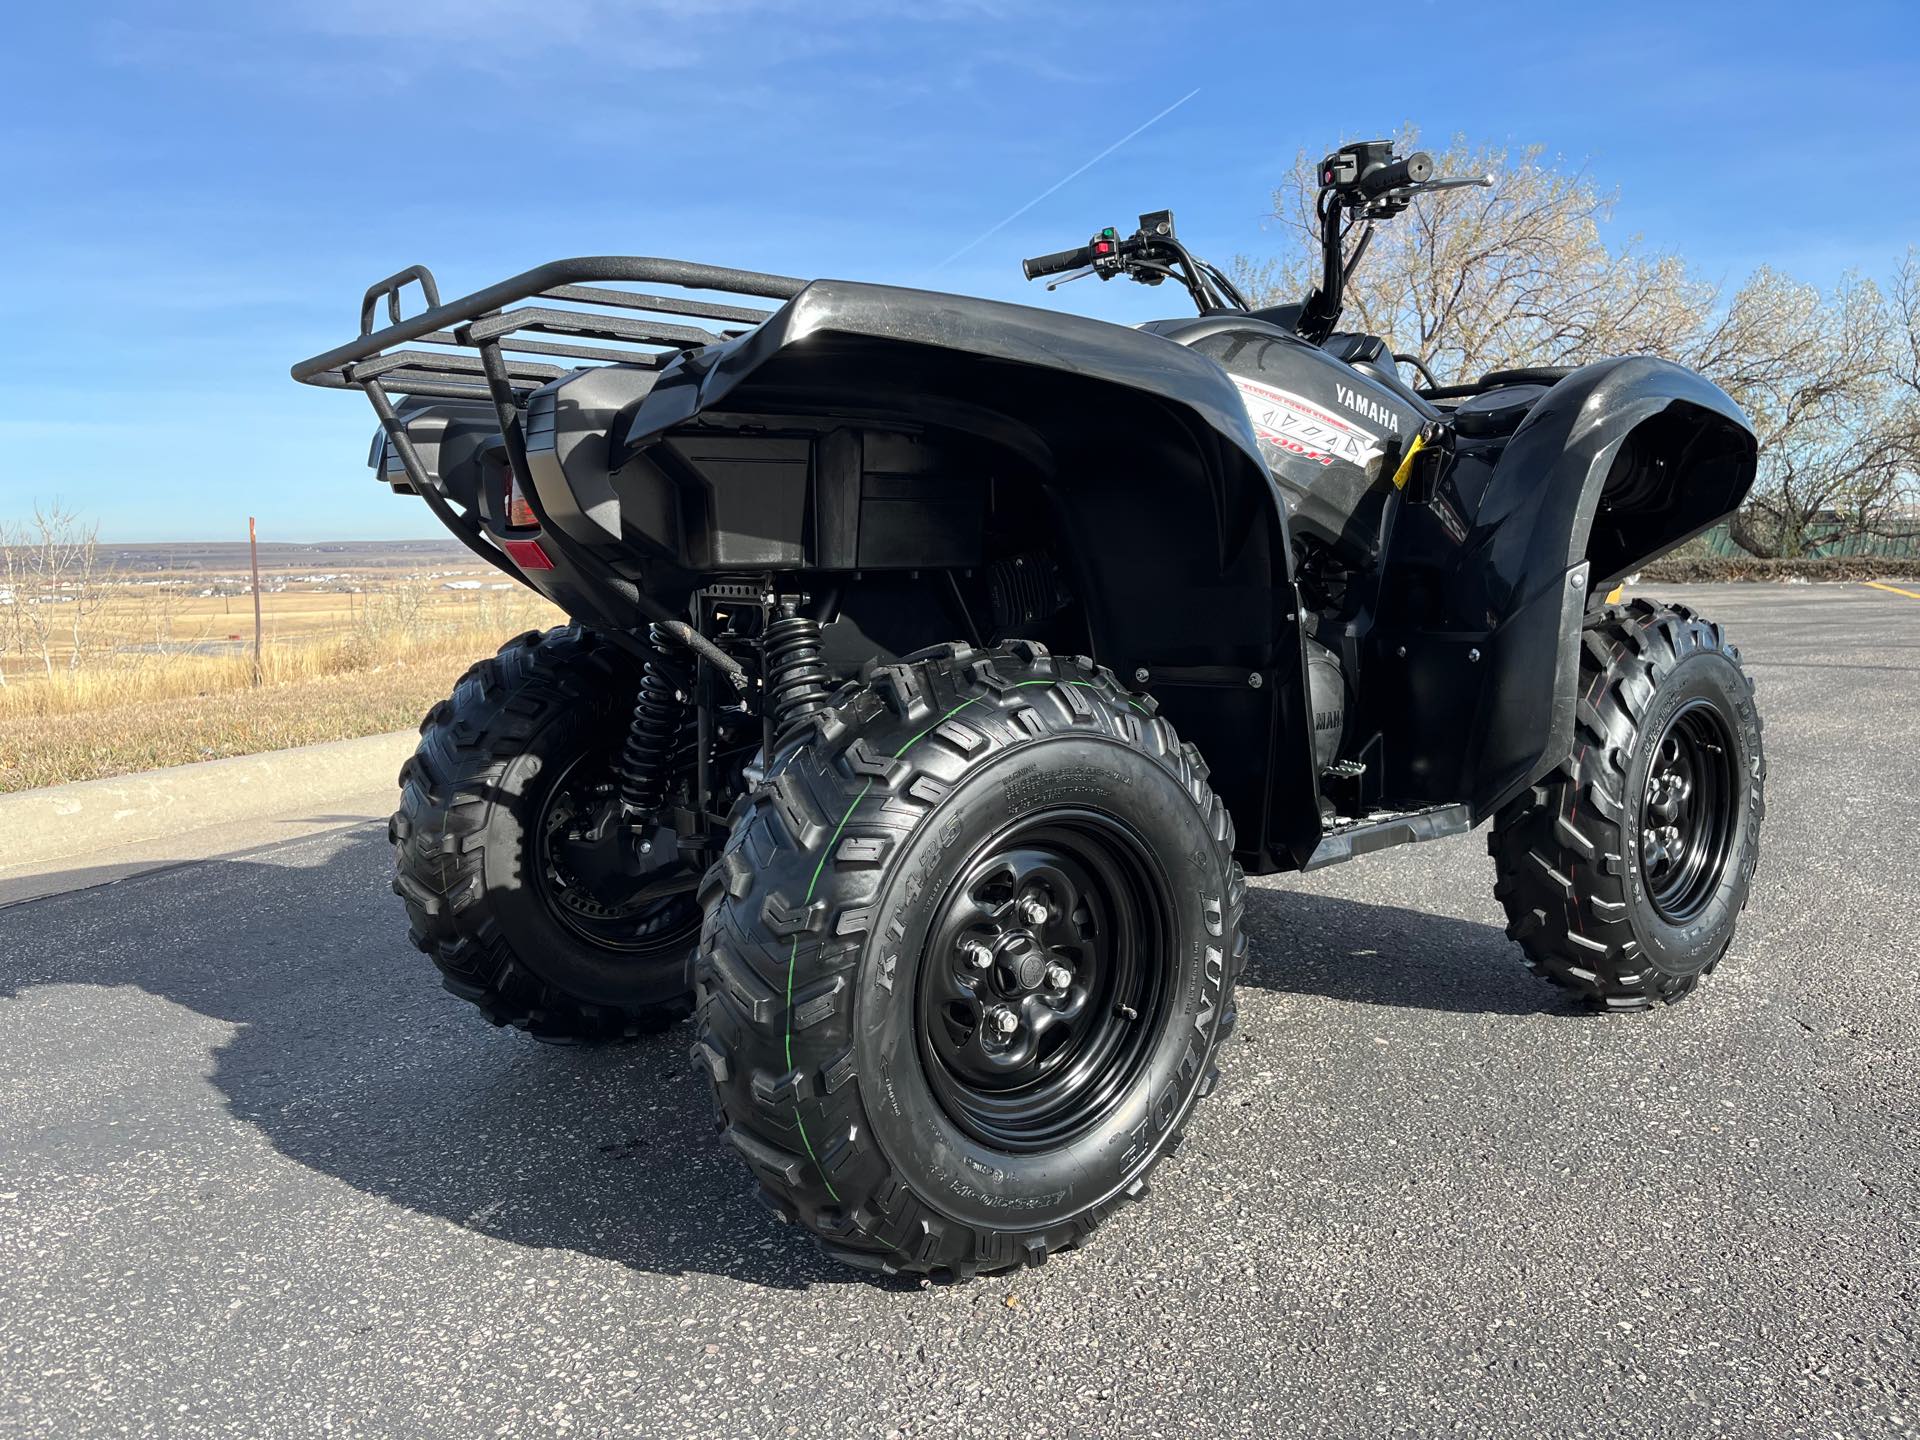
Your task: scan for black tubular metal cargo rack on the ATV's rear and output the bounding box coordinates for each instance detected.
[294,255,806,587]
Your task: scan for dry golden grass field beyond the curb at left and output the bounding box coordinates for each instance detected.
[0,561,563,791]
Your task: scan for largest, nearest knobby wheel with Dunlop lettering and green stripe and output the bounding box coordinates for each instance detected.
[693,641,1246,1279]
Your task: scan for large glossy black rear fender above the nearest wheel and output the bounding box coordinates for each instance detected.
[606,280,1319,870]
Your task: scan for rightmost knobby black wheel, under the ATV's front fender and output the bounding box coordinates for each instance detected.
[1488,599,1766,1010]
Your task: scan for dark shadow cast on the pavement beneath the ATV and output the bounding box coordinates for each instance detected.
[0,829,1565,1288]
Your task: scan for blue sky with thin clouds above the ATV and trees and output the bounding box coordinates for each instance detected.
[0,0,1920,540]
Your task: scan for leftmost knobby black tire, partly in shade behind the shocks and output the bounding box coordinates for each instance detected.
[388,626,699,1043]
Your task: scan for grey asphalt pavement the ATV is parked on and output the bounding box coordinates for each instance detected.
[0,586,1920,1440]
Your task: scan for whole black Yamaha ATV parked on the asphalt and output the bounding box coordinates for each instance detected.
[294,142,1764,1277]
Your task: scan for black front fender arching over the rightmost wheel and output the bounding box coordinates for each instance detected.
[1452,357,1757,822]
